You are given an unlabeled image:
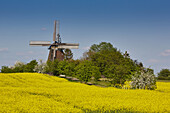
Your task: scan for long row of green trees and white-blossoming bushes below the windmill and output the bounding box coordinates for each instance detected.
[1,42,156,89]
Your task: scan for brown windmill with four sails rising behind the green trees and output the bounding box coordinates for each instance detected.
[29,20,79,61]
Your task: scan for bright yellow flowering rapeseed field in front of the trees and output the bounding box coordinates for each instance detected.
[0,73,170,113]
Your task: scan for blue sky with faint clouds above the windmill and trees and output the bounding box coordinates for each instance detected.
[0,0,170,74]
